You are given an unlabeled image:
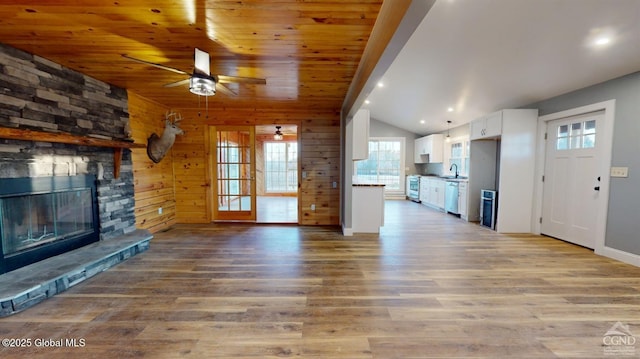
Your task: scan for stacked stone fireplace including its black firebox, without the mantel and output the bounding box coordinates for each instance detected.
[0,44,136,274]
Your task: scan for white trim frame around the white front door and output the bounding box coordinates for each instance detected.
[532,100,616,261]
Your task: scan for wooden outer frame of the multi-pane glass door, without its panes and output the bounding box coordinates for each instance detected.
[211,125,257,222]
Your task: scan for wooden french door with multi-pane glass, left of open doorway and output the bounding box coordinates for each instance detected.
[211,126,256,221]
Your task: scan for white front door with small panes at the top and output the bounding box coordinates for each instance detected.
[541,111,607,249]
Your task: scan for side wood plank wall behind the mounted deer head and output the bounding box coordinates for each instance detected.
[128,91,177,233]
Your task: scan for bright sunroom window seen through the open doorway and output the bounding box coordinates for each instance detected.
[264,141,298,193]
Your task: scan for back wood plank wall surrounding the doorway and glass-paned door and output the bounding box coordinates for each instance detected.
[173,108,340,225]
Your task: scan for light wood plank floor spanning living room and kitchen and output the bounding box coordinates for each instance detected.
[0,201,640,359]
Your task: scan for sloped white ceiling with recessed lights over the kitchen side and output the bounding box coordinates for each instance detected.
[362,0,640,135]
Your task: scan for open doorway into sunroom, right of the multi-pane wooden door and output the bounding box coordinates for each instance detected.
[255,125,300,223]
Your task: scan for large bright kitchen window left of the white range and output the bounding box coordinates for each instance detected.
[355,137,405,194]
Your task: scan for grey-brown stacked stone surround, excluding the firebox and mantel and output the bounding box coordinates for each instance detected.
[0,40,150,312]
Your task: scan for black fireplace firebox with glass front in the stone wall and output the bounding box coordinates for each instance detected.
[0,175,100,274]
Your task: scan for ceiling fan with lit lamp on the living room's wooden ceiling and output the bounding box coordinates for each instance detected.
[122,48,267,96]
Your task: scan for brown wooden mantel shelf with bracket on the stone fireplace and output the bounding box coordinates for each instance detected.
[0,127,146,178]
